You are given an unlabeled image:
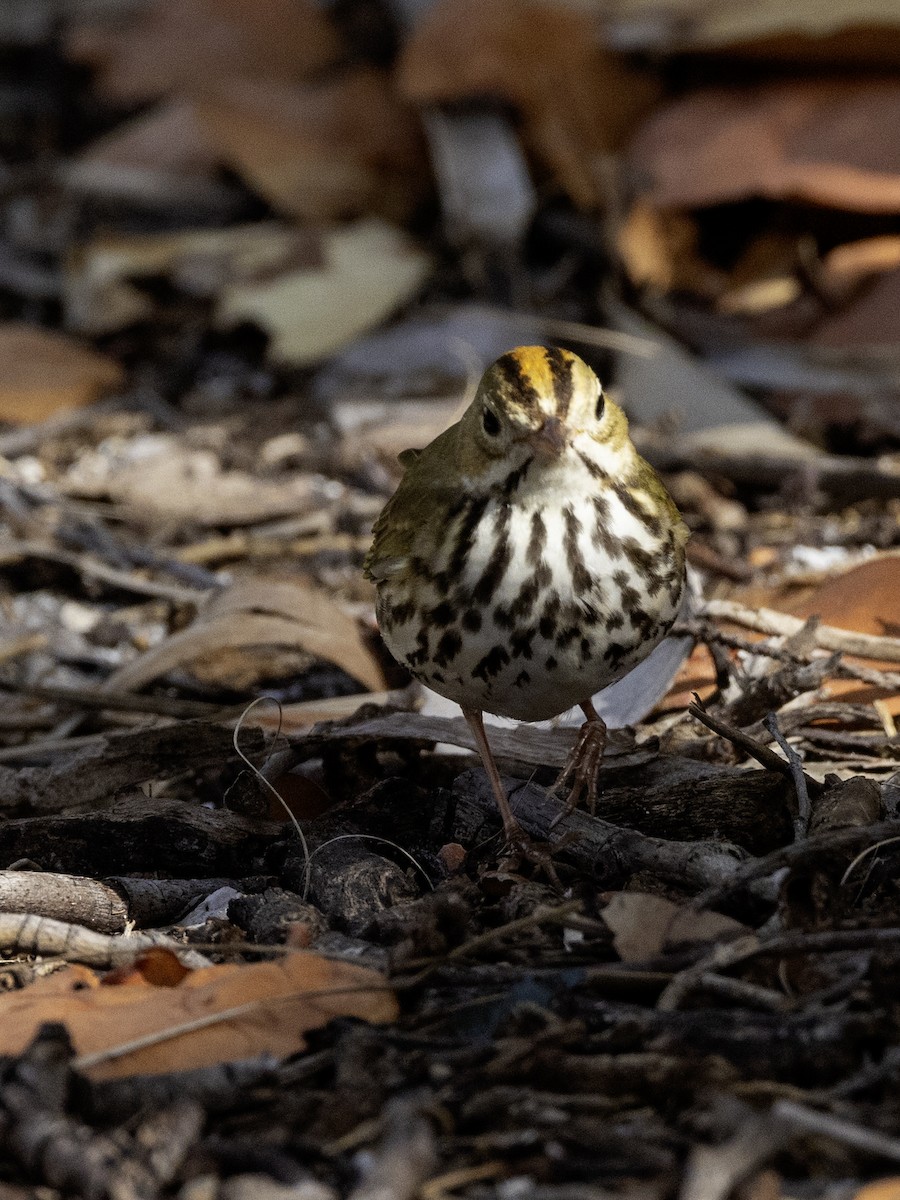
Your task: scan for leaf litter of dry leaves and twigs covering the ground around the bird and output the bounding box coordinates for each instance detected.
[0,0,900,1200]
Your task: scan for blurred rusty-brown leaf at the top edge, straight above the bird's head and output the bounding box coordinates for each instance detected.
[398,0,659,208]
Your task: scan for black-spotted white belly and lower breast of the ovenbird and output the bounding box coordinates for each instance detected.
[378,496,684,721]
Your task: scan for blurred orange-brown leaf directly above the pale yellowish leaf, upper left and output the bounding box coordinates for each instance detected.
[197,67,428,221]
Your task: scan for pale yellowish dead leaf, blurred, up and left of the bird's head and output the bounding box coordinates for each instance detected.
[216,220,431,366]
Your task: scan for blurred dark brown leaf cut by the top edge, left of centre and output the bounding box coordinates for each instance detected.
[67,0,341,103]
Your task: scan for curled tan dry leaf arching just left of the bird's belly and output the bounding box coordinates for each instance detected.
[106,577,384,691]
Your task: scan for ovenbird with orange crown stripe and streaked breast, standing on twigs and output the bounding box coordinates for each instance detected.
[365,346,688,844]
